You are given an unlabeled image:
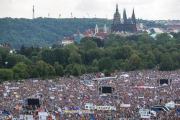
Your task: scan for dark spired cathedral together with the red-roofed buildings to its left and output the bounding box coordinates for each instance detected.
[62,5,137,45]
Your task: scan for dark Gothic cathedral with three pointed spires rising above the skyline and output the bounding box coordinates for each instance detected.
[111,5,137,33]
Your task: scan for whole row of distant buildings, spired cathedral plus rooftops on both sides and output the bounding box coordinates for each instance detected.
[62,5,180,45]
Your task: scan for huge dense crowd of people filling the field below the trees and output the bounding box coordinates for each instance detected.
[0,70,180,120]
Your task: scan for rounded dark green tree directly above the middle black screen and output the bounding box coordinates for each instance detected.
[98,57,112,71]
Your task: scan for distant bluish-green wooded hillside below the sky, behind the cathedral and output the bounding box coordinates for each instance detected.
[0,18,167,49]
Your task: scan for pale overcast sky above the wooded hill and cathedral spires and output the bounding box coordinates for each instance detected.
[0,0,180,20]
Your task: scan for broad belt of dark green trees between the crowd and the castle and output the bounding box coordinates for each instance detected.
[0,33,180,81]
